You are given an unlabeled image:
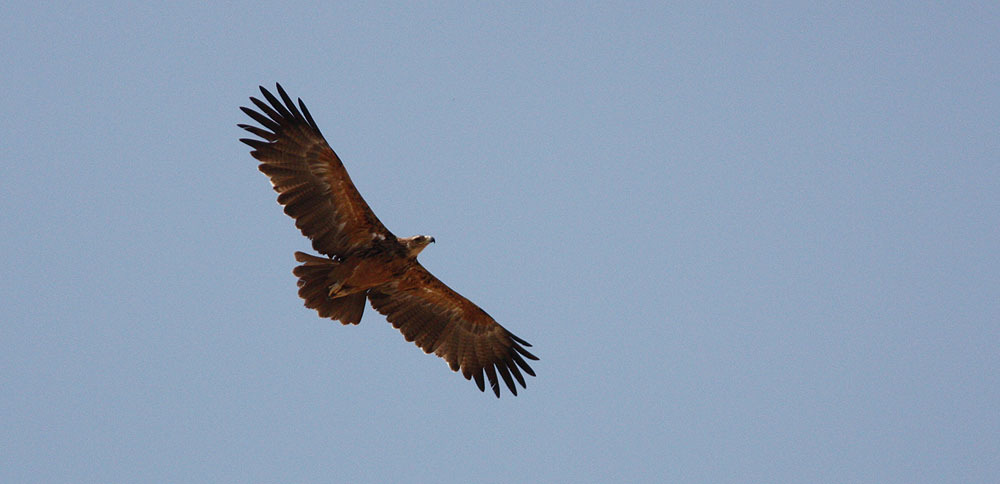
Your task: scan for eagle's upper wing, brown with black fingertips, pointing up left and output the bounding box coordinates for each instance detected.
[238,84,396,256]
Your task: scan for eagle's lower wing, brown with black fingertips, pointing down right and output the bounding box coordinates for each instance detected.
[368,263,538,398]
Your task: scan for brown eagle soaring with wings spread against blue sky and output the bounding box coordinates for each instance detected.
[237,84,538,398]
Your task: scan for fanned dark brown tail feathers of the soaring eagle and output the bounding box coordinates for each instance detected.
[292,252,368,324]
